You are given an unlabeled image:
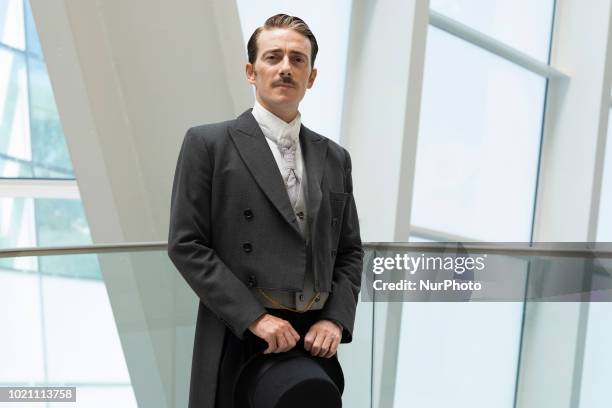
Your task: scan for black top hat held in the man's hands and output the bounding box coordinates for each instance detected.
[234,348,344,408]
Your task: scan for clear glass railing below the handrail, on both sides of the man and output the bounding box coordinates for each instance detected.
[0,243,612,408]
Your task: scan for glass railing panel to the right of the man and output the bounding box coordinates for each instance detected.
[362,243,612,408]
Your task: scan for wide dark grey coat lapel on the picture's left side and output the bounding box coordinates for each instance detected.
[230,109,300,234]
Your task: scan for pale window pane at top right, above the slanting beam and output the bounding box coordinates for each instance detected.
[430,0,555,62]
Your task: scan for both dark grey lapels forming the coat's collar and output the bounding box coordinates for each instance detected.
[230,109,327,234]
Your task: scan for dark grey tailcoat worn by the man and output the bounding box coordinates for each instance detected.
[168,110,363,408]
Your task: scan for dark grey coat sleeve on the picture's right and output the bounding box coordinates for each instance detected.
[320,150,363,343]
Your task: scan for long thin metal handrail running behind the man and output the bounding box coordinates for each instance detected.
[0,241,612,258]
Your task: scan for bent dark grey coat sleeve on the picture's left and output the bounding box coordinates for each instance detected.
[168,128,266,339]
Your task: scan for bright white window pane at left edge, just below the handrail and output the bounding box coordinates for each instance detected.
[0,266,44,382]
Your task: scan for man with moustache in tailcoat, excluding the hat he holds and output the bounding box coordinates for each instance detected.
[168,14,363,408]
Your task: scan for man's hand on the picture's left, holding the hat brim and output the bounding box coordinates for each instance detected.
[249,313,300,354]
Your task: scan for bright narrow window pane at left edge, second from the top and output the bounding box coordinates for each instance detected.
[0,48,32,177]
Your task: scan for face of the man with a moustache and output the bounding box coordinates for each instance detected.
[246,28,317,112]
